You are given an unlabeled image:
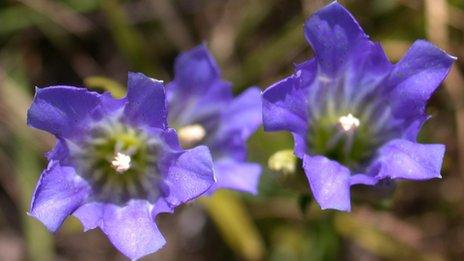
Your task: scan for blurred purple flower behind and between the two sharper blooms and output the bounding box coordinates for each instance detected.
[166,45,262,193]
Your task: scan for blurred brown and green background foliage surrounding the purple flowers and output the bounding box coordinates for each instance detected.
[0,0,464,261]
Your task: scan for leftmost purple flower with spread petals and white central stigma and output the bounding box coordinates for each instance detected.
[28,73,214,259]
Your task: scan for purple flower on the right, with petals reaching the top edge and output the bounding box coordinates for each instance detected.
[263,2,455,211]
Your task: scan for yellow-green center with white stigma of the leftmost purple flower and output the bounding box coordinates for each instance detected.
[68,118,162,203]
